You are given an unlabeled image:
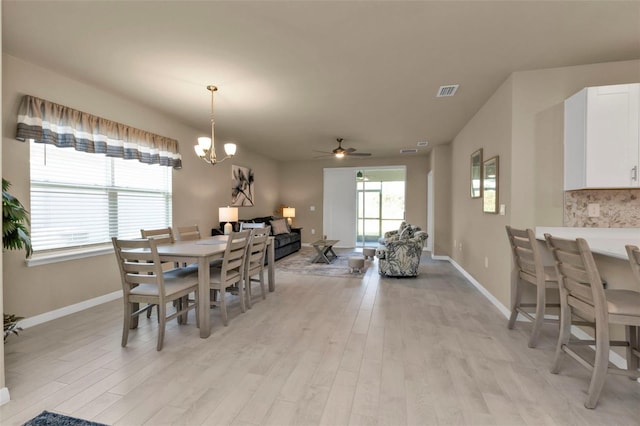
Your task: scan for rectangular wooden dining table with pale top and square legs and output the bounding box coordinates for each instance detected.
[157,235,275,339]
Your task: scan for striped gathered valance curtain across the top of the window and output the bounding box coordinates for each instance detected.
[16,95,182,169]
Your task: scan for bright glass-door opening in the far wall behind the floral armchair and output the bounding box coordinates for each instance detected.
[356,166,406,247]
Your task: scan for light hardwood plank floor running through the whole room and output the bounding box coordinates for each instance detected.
[0,256,640,426]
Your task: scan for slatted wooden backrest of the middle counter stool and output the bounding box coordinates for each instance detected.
[544,234,607,322]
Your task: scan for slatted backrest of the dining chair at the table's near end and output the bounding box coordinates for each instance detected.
[111,237,165,298]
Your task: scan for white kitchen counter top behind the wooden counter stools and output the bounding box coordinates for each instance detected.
[536,226,640,260]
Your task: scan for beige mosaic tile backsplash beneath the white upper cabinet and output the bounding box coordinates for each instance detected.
[564,189,640,228]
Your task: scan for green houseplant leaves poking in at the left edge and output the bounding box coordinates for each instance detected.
[2,178,33,341]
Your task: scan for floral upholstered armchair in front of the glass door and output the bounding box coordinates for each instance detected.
[376,231,427,277]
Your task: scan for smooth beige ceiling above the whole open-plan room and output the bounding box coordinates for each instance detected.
[2,0,640,161]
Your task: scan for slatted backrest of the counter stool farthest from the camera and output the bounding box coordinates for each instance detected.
[505,225,544,285]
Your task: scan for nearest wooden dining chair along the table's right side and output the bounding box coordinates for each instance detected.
[209,231,251,326]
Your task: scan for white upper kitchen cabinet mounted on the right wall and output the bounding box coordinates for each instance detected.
[564,83,640,190]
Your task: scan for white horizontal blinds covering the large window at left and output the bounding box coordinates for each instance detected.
[30,141,172,252]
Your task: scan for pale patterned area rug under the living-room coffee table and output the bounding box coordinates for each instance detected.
[276,247,373,278]
